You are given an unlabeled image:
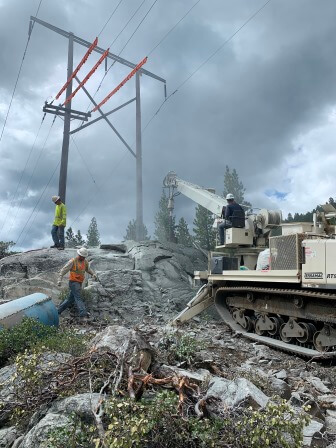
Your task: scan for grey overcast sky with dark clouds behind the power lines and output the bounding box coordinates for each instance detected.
[0,0,336,249]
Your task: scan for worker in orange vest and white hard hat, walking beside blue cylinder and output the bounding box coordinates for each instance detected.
[57,247,97,317]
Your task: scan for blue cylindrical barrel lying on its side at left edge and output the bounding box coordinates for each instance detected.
[0,293,59,330]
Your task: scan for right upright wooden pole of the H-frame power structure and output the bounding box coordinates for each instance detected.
[135,72,144,241]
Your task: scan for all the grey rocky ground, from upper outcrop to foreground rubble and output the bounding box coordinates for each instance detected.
[0,242,336,448]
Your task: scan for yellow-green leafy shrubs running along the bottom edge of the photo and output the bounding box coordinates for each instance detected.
[32,391,309,448]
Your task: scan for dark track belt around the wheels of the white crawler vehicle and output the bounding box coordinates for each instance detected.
[216,286,336,359]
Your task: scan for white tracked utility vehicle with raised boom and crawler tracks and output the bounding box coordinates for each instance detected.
[164,172,336,357]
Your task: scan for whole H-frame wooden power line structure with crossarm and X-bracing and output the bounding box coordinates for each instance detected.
[30,16,167,241]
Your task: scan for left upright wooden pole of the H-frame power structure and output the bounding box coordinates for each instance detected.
[58,33,73,203]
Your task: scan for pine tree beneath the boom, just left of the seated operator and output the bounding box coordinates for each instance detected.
[193,205,216,250]
